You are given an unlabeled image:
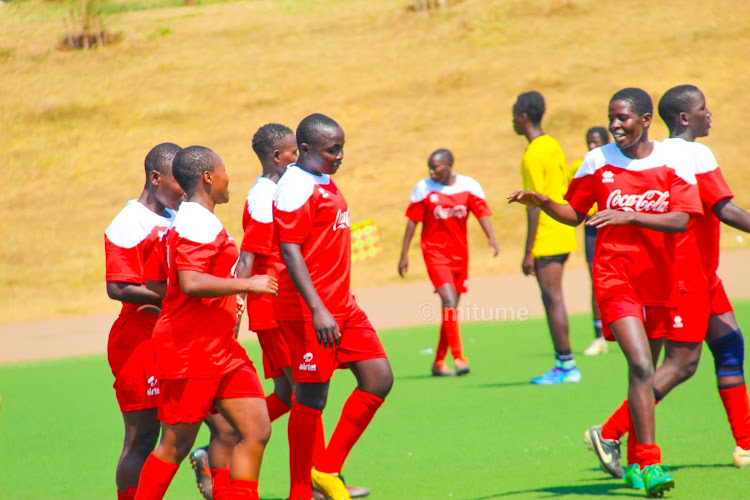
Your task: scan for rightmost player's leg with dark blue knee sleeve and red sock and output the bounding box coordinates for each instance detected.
[706,310,750,467]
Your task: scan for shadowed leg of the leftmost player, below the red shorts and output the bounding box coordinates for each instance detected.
[115,408,159,500]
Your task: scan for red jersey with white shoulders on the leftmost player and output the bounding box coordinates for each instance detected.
[104,200,175,315]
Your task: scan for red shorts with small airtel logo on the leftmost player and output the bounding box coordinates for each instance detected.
[107,311,159,412]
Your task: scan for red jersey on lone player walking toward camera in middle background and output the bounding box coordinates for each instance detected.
[406,175,492,267]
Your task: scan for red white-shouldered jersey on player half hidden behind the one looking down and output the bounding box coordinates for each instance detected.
[240,176,284,331]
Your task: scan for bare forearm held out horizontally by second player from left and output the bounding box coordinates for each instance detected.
[177,270,279,298]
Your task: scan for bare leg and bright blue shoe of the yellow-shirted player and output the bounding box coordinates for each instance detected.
[531,254,581,385]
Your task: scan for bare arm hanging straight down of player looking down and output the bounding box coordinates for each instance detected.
[281,241,341,348]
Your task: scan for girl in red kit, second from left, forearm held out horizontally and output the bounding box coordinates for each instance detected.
[135,146,277,500]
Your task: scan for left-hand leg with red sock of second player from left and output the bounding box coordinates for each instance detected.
[135,422,201,500]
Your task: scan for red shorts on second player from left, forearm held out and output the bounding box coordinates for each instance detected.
[158,363,266,425]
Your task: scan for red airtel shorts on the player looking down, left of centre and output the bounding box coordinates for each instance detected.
[279,305,388,383]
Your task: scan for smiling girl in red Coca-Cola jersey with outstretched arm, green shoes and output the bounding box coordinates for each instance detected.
[508,88,702,496]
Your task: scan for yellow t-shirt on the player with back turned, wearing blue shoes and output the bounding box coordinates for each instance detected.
[521,134,578,257]
